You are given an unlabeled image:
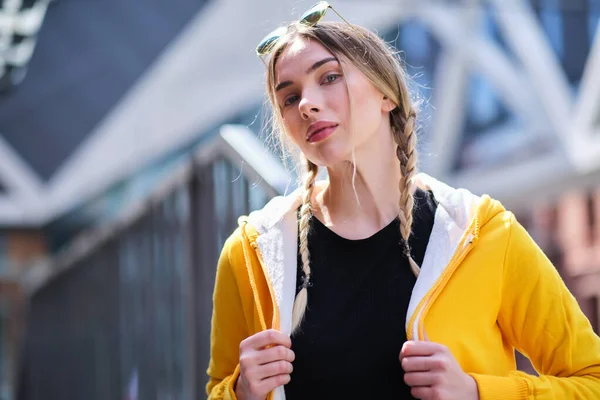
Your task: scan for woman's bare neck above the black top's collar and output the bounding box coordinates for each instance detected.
[316,125,401,231]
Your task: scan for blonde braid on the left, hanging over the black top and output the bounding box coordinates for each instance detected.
[292,160,319,332]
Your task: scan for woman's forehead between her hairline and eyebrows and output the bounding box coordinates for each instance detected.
[275,38,335,82]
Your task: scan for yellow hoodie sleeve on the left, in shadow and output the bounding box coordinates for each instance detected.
[206,230,249,400]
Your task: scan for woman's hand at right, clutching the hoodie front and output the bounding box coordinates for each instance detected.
[400,341,479,400]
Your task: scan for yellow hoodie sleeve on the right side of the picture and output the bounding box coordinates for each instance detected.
[471,212,600,400]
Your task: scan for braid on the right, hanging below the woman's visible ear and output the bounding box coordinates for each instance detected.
[391,108,421,276]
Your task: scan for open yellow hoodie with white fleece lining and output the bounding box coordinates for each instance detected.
[207,174,600,400]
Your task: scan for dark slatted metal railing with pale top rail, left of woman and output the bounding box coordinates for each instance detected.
[17,126,289,400]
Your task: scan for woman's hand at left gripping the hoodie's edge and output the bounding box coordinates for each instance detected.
[235,329,294,400]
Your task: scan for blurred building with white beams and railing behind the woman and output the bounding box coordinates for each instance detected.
[0,0,600,399]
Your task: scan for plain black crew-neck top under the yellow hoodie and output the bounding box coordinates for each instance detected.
[285,190,437,400]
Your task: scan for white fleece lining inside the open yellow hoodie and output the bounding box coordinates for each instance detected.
[248,173,481,400]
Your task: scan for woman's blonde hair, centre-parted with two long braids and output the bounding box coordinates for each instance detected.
[267,22,420,331]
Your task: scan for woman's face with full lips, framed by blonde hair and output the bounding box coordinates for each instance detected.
[275,39,395,167]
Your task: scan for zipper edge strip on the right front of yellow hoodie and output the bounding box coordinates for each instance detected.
[406,218,479,340]
